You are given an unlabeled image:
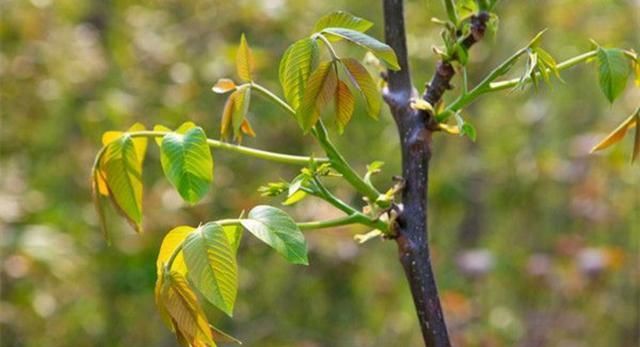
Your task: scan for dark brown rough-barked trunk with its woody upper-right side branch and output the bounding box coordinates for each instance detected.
[383,0,489,347]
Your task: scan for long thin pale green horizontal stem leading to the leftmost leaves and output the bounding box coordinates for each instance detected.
[122,130,329,166]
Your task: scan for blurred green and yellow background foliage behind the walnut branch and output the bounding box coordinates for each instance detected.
[0,0,640,347]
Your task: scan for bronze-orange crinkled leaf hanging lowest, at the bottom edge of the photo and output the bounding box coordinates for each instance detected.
[159,271,216,347]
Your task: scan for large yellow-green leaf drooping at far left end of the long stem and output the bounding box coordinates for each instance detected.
[100,134,146,232]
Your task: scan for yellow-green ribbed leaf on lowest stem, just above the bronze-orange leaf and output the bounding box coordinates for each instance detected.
[182,223,238,316]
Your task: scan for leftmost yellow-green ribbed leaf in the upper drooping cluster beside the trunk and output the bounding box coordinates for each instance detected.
[280,38,318,109]
